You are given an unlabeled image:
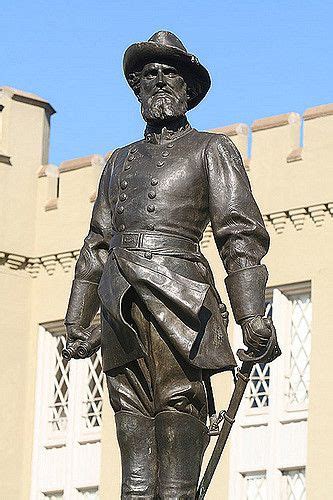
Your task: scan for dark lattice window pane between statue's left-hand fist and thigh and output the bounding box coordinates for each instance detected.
[82,351,103,429]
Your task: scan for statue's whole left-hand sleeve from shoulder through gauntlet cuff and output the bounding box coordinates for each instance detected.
[65,151,117,328]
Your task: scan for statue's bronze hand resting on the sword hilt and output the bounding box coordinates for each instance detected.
[241,316,272,355]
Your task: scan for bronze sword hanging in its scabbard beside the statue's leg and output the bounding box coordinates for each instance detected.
[196,322,281,500]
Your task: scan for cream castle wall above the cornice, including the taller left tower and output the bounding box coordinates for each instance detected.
[0,87,333,264]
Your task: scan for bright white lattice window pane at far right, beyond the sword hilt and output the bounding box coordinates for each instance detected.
[288,293,312,405]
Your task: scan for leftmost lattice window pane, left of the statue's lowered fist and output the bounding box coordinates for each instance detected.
[48,335,69,432]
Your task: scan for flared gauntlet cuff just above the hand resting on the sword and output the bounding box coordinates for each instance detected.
[225,264,268,323]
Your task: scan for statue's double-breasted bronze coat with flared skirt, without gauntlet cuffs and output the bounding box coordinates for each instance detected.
[75,124,269,372]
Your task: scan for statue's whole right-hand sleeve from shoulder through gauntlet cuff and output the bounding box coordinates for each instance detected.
[205,135,269,322]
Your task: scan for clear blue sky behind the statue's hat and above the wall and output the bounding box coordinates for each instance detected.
[0,0,333,164]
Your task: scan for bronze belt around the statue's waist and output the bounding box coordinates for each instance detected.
[110,231,199,252]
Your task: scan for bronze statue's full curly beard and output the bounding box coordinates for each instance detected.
[141,92,187,123]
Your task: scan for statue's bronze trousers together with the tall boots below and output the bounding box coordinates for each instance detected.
[107,295,208,500]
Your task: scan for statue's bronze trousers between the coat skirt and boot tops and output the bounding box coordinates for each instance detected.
[107,296,207,423]
